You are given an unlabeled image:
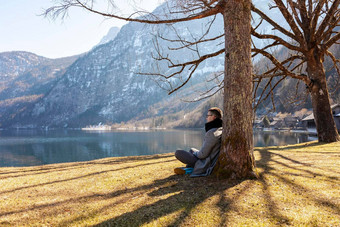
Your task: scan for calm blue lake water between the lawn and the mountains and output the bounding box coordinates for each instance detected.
[0,129,316,167]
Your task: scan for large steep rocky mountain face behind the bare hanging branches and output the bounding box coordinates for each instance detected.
[3,1,227,127]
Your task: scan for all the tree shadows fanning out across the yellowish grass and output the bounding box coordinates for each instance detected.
[0,145,339,227]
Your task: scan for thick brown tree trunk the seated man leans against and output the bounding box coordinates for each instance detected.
[216,0,254,178]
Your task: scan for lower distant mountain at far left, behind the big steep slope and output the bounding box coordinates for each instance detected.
[0,51,78,127]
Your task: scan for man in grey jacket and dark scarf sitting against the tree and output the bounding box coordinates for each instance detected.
[174,107,223,177]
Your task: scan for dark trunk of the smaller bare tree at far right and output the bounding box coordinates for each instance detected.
[307,49,340,143]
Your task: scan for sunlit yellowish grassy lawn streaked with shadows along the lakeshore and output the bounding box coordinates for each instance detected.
[0,142,340,227]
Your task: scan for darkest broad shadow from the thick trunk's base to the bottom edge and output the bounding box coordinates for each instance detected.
[91,175,240,226]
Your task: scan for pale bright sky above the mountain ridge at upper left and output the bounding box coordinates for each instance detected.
[0,0,162,58]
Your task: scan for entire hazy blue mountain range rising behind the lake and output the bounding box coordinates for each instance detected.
[0,0,338,128]
